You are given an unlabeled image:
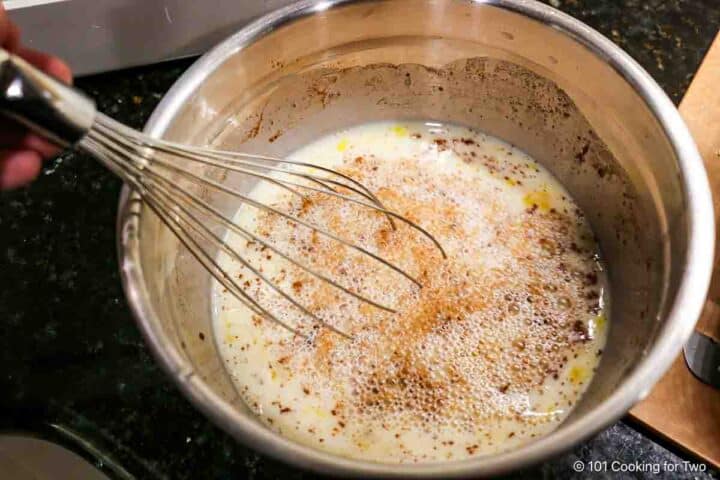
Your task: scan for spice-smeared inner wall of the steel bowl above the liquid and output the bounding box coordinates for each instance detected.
[129,0,688,466]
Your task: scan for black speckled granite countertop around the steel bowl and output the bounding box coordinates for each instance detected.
[0,0,720,479]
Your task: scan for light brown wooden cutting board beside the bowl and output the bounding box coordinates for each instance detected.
[630,35,720,468]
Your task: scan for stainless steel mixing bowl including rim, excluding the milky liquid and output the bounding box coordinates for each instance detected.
[118,0,714,477]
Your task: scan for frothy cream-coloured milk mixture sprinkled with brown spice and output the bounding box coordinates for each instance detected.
[214,122,608,463]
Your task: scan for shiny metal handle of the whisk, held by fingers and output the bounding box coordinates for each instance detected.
[0,48,96,147]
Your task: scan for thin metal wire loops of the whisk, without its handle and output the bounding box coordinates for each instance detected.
[79,113,446,338]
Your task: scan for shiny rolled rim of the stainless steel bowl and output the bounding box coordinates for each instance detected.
[117,0,715,478]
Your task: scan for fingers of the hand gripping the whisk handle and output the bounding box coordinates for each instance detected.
[0,2,72,190]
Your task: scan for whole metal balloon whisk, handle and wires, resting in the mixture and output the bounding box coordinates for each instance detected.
[0,49,446,338]
